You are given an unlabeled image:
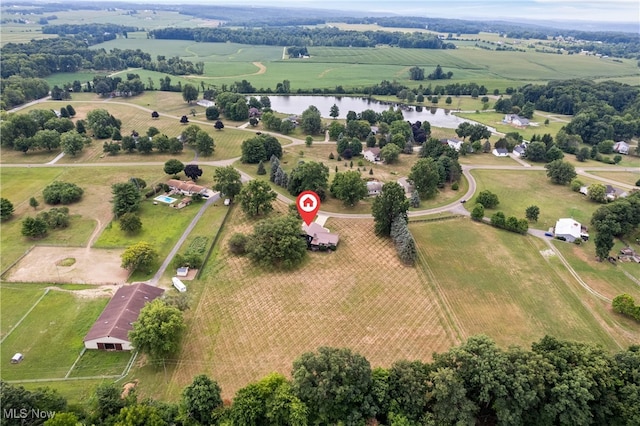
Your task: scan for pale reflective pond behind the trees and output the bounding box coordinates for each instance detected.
[262,96,494,131]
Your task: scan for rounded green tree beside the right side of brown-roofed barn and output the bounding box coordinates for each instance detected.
[129,299,185,361]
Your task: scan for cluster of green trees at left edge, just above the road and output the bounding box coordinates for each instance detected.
[0,105,91,155]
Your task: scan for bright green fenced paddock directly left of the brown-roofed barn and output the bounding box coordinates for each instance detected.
[0,291,108,380]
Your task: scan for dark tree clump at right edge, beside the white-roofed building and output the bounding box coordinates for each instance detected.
[591,192,640,260]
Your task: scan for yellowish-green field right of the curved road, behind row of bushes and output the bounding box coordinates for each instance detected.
[467,168,599,230]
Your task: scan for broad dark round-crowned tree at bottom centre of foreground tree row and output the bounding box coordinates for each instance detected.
[292,347,375,424]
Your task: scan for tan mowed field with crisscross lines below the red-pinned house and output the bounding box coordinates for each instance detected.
[135,203,458,400]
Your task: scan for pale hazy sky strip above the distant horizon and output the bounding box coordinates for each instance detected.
[166,0,640,22]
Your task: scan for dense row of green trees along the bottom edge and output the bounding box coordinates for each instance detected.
[7,334,640,426]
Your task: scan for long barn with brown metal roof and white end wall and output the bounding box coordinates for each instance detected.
[84,283,164,351]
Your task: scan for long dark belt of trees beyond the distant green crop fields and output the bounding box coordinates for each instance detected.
[148,27,455,49]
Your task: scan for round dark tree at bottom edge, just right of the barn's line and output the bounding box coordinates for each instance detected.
[182,374,222,425]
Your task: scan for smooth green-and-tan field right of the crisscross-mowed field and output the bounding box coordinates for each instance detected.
[410,219,618,350]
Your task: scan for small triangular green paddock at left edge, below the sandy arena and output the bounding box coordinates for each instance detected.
[0,283,49,337]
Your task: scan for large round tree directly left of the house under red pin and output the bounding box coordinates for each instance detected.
[248,215,307,269]
